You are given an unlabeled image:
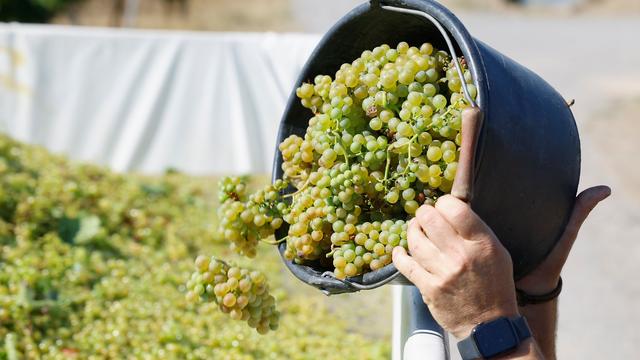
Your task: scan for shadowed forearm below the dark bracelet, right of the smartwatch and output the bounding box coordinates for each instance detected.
[518,299,558,360]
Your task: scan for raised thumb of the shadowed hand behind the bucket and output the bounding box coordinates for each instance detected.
[553,185,611,260]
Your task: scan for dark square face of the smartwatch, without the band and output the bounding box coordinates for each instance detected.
[473,318,518,358]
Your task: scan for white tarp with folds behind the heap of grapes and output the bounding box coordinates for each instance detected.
[0,24,319,174]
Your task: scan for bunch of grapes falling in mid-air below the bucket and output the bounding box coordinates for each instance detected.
[182,256,280,334]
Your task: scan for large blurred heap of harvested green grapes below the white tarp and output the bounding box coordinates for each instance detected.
[0,134,390,360]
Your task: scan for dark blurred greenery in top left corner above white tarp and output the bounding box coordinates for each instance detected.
[0,0,83,23]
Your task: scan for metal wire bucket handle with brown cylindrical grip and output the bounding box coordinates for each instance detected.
[322,0,482,295]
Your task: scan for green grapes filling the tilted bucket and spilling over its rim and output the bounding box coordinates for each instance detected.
[210,42,477,279]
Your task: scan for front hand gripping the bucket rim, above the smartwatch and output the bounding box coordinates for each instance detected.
[393,195,518,338]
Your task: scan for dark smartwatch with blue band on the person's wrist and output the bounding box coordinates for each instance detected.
[458,316,531,360]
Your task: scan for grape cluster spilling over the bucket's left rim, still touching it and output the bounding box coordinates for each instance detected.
[218,177,287,258]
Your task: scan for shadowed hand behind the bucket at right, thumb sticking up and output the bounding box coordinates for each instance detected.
[516,185,611,295]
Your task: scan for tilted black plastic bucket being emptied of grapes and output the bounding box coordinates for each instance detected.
[273,0,580,294]
